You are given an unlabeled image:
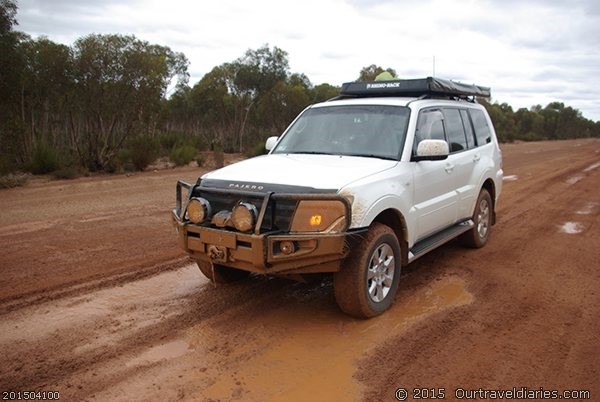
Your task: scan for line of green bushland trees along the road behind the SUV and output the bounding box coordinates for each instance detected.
[0,0,600,174]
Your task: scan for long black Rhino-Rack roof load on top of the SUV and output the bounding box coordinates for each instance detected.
[340,77,491,98]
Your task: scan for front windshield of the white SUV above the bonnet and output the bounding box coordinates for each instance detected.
[273,105,409,160]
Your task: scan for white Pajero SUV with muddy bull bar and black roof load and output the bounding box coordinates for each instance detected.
[173,77,503,318]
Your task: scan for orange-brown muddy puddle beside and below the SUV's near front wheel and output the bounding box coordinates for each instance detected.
[196,277,473,401]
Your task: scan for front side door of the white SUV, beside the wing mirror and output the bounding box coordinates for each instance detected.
[411,108,457,241]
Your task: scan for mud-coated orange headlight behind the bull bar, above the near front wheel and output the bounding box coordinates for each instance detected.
[290,200,347,233]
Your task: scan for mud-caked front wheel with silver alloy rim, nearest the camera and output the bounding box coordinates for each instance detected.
[333,223,402,318]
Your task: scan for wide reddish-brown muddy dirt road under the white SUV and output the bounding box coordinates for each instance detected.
[0,140,600,401]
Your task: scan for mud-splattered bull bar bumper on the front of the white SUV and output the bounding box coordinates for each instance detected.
[172,181,361,274]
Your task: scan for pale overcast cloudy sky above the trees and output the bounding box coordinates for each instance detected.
[16,0,600,121]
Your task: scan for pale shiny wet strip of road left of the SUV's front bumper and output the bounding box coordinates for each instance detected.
[0,266,207,353]
